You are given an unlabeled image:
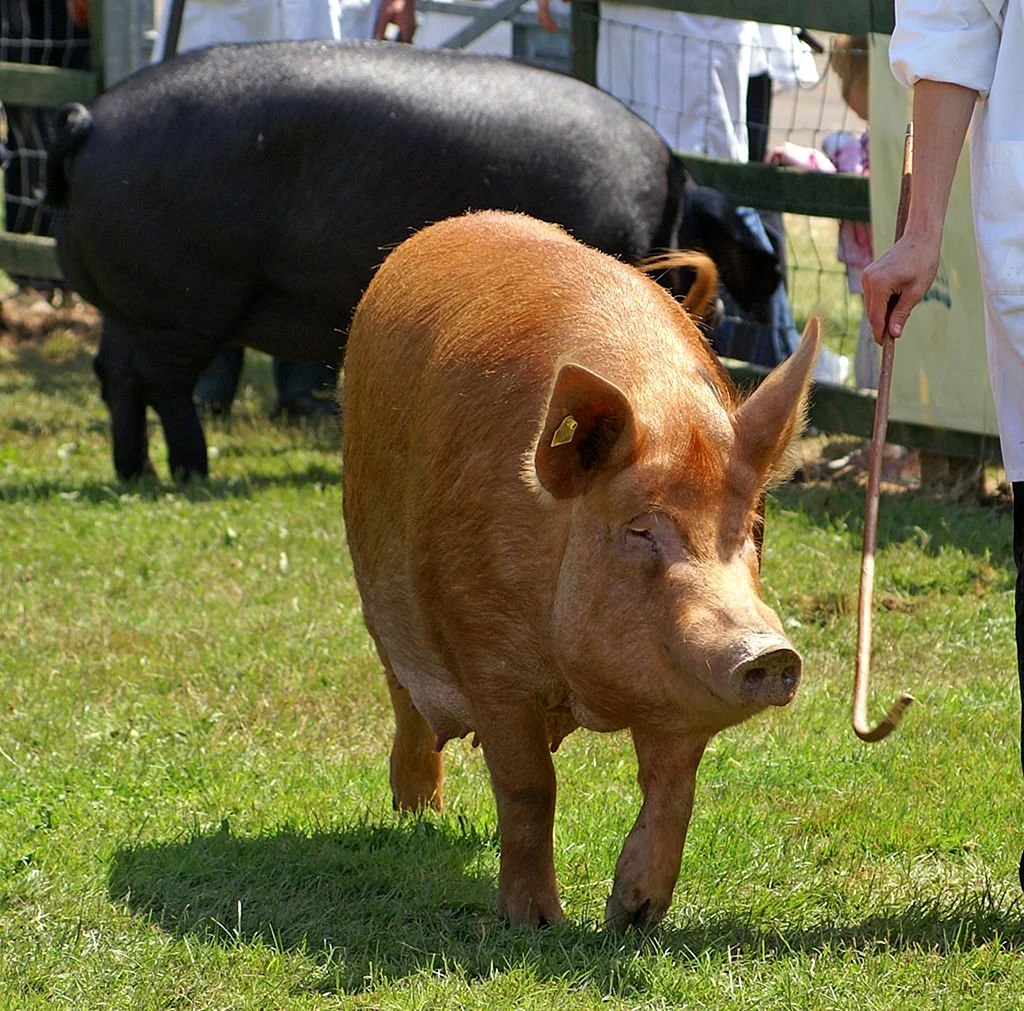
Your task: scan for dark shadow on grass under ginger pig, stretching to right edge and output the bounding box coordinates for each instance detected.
[110,817,1024,999]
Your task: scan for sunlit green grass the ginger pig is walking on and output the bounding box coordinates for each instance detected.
[0,337,1024,1011]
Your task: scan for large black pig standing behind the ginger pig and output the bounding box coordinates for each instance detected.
[47,42,778,478]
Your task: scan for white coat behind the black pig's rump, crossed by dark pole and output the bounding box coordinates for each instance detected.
[153,0,379,61]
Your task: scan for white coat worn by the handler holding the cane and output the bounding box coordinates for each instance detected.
[889,0,1024,481]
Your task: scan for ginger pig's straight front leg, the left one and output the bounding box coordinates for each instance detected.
[473,692,564,927]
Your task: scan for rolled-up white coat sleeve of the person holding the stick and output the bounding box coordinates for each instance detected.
[889,0,1001,98]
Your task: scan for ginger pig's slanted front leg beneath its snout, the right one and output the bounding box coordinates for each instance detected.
[604,730,710,931]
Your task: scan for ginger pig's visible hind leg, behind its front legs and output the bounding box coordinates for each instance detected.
[378,663,444,811]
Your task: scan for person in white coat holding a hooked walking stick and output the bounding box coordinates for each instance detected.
[862,0,1024,887]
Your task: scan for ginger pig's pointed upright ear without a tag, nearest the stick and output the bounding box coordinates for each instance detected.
[733,317,820,480]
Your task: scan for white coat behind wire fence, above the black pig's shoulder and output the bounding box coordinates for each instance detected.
[597,2,760,162]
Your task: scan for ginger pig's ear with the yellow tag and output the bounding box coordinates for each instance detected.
[535,365,636,499]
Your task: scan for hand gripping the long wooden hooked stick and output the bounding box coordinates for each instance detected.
[860,233,941,344]
